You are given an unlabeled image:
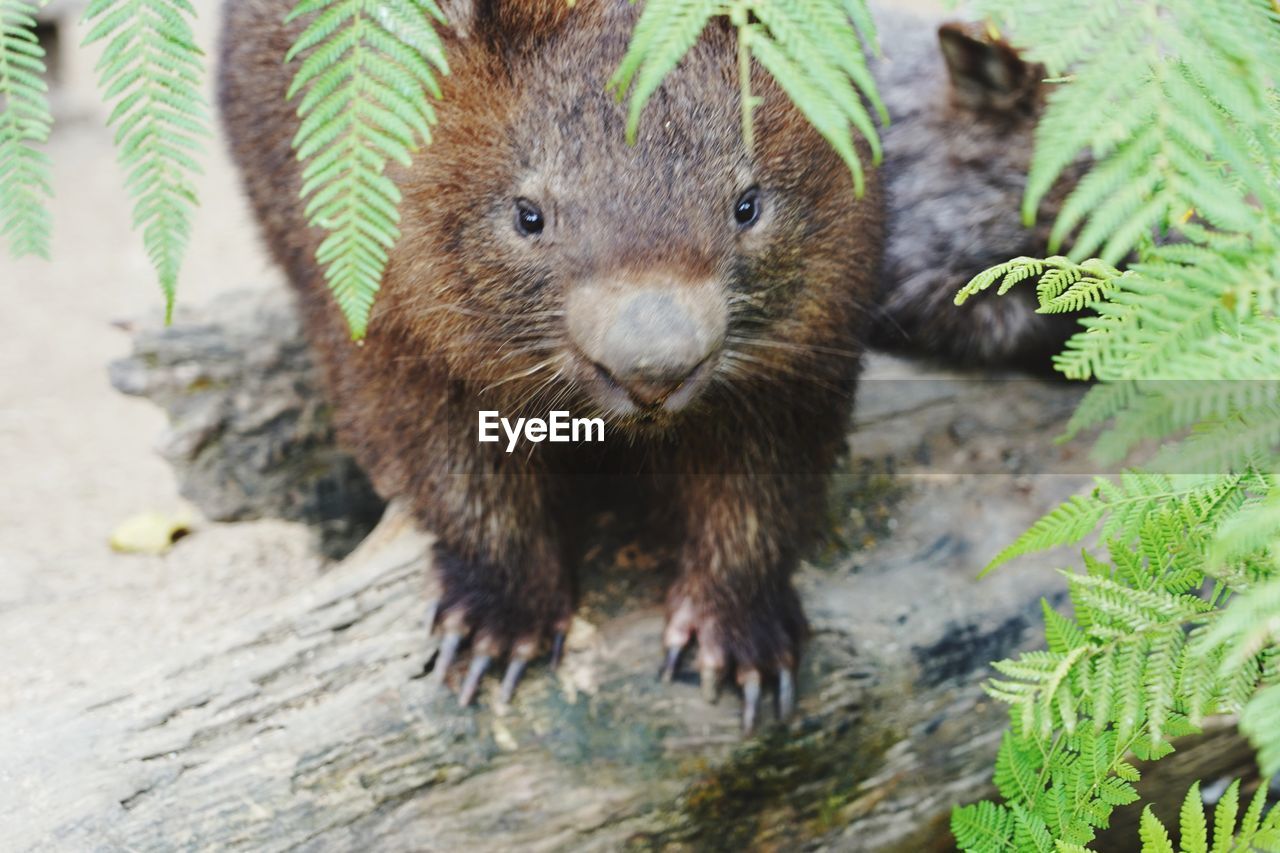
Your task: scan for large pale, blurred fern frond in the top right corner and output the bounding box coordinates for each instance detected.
[977,0,1280,263]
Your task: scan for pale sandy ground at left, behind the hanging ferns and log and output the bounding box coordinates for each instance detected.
[0,0,934,712]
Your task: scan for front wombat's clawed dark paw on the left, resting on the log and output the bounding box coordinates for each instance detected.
[430,547,573,706]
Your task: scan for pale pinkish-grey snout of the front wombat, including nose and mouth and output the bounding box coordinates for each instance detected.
[567,282,727,410]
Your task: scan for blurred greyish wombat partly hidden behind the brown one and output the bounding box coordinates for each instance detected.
[868,4,1082,363]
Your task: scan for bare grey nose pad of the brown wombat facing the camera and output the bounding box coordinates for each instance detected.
[596,292,714,406]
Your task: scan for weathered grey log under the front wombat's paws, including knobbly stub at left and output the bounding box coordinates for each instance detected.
[0,289,1251,850]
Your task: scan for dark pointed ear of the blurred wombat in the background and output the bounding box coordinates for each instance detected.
[938,23,1044,113]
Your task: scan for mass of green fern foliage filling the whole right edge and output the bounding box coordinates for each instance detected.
[956,0,1280,853]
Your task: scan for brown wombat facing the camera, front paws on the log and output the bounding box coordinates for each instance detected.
[220,0,1070,730]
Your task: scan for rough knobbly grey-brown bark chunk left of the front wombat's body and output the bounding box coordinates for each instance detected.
[110,291,383,557]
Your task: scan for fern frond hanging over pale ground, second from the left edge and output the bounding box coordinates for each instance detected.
[84,0,210,321]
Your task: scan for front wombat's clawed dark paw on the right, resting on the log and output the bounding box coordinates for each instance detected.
[662,579,809,734]
